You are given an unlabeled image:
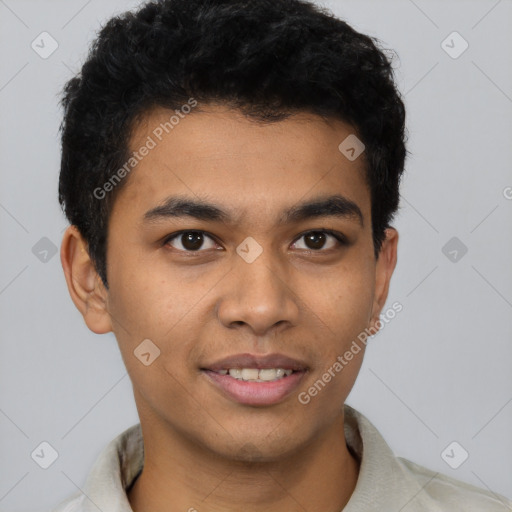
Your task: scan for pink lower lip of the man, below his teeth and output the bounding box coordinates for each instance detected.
[202,370,305,405]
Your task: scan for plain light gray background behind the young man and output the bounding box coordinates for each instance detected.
[0,0,512,511]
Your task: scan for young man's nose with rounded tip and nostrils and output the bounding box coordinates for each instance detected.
[217,251,300,336]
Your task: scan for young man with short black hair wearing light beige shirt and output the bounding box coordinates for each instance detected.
[56,0,510,512]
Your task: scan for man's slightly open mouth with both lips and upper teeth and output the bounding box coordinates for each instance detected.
[200,354,308,406]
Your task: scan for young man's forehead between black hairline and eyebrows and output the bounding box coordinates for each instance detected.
[114,105,370,227]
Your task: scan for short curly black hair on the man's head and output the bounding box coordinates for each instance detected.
[59,0,407,288]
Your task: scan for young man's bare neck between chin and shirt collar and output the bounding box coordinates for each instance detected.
[128,416,359,512]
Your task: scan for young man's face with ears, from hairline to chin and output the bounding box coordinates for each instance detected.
[62,105,397,460]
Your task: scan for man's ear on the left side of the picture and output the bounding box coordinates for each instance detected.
[60,225,112,334]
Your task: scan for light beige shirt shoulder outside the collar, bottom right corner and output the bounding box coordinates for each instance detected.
[397,457,512,512]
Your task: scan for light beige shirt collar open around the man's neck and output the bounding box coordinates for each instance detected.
[73,404,448,512]
